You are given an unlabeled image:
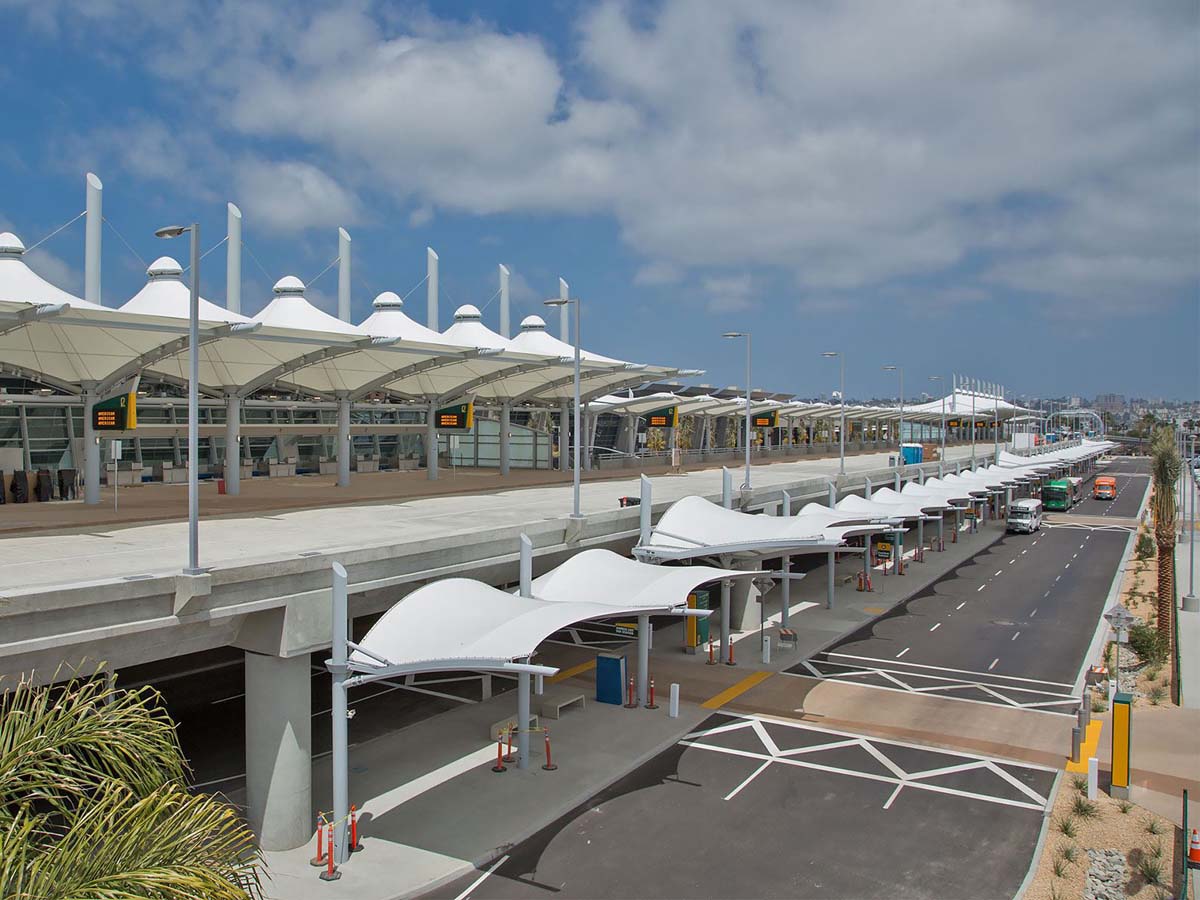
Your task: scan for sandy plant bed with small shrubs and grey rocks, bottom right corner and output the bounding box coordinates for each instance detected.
[1025,773,1178,900]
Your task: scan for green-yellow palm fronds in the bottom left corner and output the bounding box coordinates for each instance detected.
[0,676,262,900]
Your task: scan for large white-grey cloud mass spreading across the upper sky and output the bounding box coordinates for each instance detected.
[18,0,1200,314]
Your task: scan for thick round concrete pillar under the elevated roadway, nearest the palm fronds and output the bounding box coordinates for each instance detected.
[246,653,312,850]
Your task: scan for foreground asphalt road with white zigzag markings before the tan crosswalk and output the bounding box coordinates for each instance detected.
[428,714,1054,900]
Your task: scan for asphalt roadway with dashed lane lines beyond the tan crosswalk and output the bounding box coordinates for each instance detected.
[790,460,1147,714]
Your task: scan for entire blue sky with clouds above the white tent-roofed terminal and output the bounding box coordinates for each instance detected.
[0,0,1200,397]
